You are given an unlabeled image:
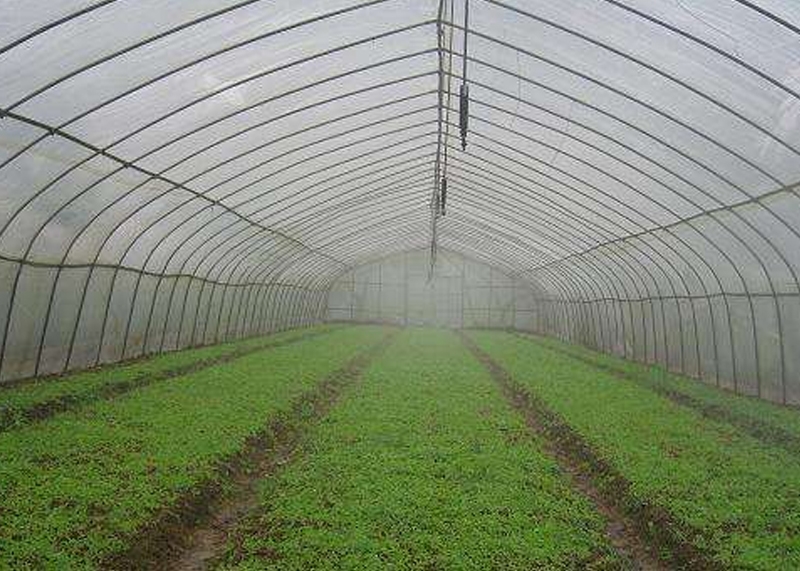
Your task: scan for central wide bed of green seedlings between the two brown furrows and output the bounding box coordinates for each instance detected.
[221,330,621,571]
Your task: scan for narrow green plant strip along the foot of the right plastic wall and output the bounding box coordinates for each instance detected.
[525,335,800,449]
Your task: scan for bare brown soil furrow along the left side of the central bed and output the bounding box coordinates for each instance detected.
[112,332,396,571]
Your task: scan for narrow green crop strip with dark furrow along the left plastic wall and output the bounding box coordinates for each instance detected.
[0,325,340,430]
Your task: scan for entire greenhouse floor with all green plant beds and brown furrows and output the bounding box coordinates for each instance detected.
[0,326,800,570]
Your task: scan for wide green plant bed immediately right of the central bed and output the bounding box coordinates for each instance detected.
[470,331,800,570]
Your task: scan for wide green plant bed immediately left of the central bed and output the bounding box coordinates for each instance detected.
[0,327,383,569]
